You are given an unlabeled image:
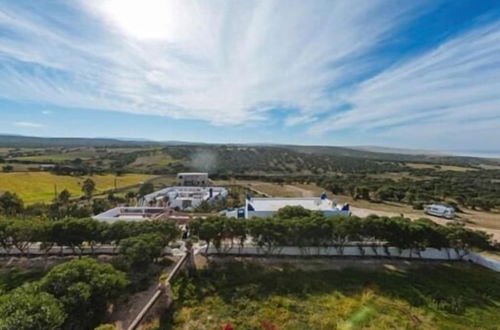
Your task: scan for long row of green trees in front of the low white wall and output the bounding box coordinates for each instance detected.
[189,206,492,254]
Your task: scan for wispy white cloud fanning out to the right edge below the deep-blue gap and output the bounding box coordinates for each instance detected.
[310,22,500,147]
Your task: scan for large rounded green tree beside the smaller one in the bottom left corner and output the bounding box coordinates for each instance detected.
[40,258,128,330]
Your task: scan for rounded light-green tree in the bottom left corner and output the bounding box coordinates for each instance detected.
[0,285,67,330]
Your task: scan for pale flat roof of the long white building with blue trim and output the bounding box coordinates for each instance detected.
[247,197,336,211]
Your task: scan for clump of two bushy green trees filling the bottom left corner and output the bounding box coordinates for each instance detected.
[0,258,129,330]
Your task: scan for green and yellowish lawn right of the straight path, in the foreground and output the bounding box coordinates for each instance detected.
[162,261,500,330]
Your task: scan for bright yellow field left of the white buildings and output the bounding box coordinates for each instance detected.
[0,172,154,204]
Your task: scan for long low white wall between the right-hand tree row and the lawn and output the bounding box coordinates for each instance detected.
[201,245,500,272]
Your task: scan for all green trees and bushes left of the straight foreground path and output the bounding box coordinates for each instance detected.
[0,219,180,330]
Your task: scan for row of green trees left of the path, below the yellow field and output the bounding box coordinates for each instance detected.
[0,218,180,266]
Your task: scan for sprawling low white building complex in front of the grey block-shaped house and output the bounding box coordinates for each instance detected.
[139,186,228,210]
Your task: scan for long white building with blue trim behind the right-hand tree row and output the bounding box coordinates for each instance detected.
[225,195,350,219]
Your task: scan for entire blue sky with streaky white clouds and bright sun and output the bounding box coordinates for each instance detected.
[0,0,500,152]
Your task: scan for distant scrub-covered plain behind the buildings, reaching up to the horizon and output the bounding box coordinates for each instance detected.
[0,141,500,211]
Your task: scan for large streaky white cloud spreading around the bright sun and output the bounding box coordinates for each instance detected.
[0,0,419,125]
